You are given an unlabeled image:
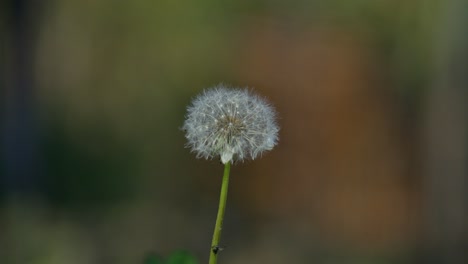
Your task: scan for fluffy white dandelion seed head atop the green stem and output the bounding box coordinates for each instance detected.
[182,85,279,164]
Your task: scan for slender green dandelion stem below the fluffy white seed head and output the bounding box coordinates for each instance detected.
[209,162,231,264]
